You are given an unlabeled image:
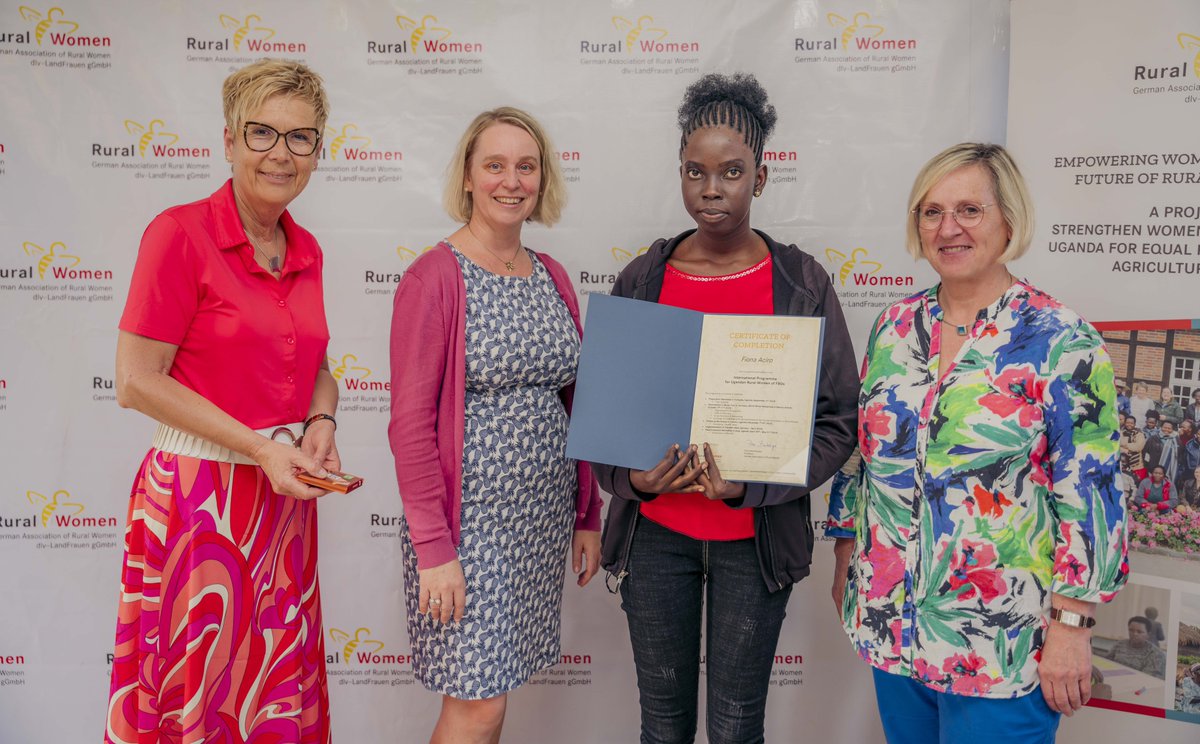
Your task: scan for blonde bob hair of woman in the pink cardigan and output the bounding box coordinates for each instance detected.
[442,106,566,227]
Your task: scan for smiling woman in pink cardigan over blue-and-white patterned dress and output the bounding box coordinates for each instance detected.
[388,108,601,743]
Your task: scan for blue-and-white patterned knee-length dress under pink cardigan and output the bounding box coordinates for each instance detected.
[402,250,580,700]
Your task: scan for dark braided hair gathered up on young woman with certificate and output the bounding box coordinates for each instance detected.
[679,72,775,168]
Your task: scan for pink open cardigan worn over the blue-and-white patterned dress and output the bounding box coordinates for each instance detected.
[388,242,604,569]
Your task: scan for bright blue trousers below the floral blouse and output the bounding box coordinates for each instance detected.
[872,670,1060,744]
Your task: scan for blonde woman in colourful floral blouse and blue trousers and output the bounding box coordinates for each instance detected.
[827,143,1128,744]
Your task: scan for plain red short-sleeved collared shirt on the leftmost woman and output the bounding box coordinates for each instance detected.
[120,181,329,428]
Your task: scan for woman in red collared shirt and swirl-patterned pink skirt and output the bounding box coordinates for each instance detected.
[104,60,341,744]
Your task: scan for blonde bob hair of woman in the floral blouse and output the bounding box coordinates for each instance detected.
[905,142,1033,263]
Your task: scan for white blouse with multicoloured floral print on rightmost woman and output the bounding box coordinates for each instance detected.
[827,282,1128,698]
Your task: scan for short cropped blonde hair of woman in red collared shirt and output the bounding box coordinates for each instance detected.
[221,59,329,138]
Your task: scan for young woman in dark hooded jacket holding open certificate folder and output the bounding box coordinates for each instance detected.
[594,74,857,744]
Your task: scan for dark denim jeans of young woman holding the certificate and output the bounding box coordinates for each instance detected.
[620,518,792,744]
